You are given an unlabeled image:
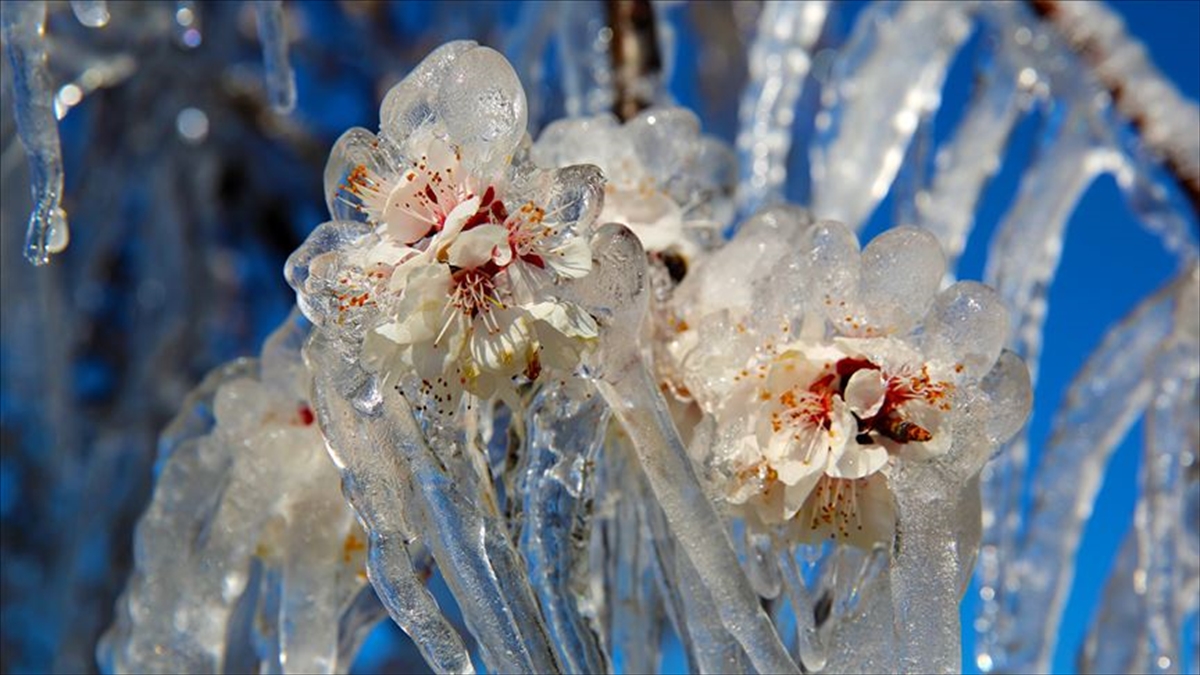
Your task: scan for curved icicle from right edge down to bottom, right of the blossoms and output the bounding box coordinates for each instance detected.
[996,268,1200,673]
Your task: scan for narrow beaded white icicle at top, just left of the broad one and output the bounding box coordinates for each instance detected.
[738,0,829,214]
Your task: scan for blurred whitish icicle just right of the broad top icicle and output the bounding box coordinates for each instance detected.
[917,22,1033,280]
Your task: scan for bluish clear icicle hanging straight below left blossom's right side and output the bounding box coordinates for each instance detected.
[518,381,609,673]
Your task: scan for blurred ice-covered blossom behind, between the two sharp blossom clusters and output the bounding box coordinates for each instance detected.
[532,108,737,264]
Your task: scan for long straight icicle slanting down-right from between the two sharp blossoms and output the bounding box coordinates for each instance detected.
[580,225,797,673]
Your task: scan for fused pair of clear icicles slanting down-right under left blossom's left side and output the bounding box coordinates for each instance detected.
[306,331,560,673]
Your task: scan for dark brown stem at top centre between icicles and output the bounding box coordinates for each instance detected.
[606,0,662,121]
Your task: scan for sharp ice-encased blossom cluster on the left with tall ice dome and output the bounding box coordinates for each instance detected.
[288,42,604,400]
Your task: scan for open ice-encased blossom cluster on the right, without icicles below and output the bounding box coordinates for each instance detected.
[670,209,1008,546]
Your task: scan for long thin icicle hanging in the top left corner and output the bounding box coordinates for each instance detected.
[0,0,70,265]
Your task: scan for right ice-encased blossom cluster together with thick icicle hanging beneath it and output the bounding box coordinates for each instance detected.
[670,210,1031,671]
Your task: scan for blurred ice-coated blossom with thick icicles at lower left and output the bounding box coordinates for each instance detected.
[98,317,366,673]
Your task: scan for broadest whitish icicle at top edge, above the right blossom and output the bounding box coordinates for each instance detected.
[810,2,971,229]
